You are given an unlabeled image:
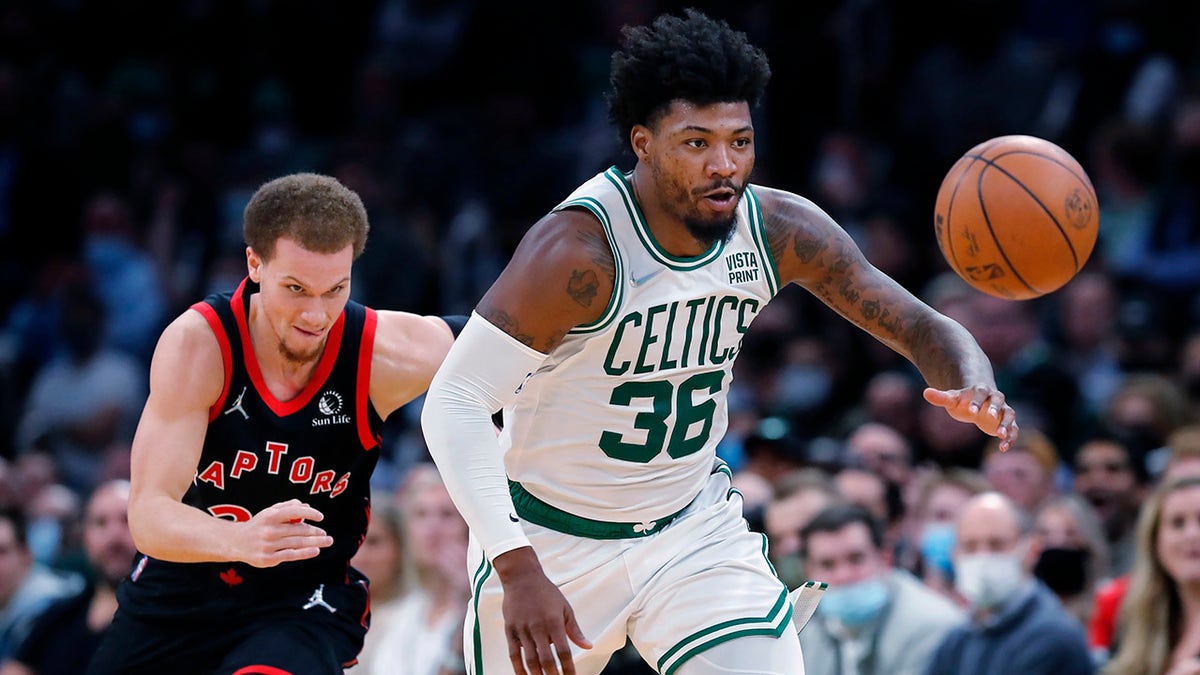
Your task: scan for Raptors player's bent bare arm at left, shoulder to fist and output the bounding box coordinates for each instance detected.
[130,310,332,567]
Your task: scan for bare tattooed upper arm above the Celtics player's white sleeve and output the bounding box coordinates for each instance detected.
[475,209,617,353]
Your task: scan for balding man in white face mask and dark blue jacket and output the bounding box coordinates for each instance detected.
[926,491,1094,675]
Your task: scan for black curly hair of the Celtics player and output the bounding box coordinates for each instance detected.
[607,8,770,142]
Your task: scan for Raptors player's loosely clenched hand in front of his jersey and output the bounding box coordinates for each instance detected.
[234,500,334,567]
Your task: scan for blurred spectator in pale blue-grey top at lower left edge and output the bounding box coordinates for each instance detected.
[0,509,83,663]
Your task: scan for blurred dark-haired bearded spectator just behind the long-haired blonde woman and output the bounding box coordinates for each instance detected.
[1074,432,1150,577]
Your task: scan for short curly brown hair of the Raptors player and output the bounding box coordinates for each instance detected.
[242,173,371,261]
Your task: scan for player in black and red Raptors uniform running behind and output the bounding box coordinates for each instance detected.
[89,174,457,675]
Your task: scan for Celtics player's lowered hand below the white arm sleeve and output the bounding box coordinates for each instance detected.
[493,546,592,675]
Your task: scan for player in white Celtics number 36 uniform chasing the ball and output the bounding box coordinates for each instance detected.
[422,11,1018,675]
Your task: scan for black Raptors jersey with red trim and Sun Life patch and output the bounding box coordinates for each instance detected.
[119,279,383,616]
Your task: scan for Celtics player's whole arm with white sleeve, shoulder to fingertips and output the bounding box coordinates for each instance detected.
[421,210,614,674]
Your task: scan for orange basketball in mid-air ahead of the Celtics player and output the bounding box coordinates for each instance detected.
[934,136,1099,300]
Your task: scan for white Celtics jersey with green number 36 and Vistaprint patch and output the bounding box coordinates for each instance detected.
[500,167,779,522]
